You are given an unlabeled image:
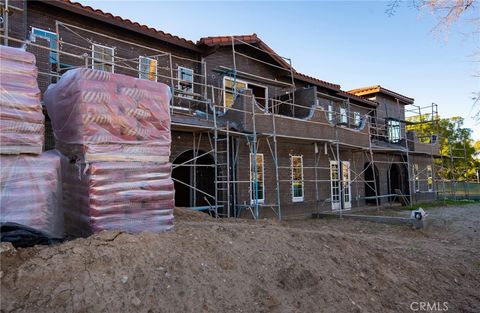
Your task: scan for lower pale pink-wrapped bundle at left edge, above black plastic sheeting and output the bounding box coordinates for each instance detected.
[0,151,63,238]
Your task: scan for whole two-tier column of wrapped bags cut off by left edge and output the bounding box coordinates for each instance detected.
[0,46,63,237]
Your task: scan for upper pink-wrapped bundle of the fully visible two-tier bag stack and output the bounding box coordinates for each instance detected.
[44,69,171,161]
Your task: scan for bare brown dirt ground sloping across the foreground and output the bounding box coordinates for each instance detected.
[0,204,480,313]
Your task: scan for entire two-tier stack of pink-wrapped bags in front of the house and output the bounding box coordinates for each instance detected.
[44,69,174,236]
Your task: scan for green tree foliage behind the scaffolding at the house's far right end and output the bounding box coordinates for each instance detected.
[407,114,480,181]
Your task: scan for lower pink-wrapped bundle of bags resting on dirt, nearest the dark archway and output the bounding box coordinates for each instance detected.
[62,152,174,237]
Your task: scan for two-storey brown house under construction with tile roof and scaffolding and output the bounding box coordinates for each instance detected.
[1,0,446,219]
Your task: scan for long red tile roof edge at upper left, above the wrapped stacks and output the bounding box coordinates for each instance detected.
[44,0,199,51]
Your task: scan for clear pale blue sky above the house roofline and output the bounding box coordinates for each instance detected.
[79,0,480,140]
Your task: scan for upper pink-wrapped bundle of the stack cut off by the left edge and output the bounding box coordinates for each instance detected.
[0,46,45,154]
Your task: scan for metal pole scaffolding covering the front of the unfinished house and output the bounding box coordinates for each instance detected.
[1,8,474,219]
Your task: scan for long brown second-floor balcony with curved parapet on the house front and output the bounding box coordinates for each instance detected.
[220,87,369,148]
